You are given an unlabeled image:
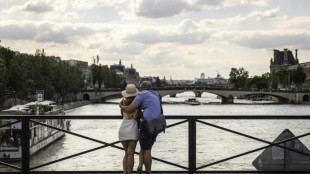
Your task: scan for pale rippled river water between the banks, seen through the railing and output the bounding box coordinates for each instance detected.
[2,92,310,171]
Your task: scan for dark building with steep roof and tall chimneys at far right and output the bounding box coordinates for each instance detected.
[270,49,310,90]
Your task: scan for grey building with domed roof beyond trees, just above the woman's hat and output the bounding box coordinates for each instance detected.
[110,60,140,86]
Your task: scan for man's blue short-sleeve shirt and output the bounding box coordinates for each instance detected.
[133,90,161,120]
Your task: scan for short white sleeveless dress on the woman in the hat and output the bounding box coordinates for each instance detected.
[118,109,138,141]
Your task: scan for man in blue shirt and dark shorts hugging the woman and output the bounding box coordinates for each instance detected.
[119,81,161,174]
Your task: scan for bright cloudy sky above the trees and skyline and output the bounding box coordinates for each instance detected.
[0,0,310,80]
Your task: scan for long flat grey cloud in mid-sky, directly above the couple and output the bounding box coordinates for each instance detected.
[125,31,210,44]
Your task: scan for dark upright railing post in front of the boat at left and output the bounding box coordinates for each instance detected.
[22,117,30,173]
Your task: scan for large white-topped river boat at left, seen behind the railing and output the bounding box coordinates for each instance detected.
[0,102,66,162]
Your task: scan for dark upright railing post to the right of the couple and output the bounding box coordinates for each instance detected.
[188,118,196,174]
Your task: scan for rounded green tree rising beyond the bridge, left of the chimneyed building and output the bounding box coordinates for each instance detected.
[229,67,249,88]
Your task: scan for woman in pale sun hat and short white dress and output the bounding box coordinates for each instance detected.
[118,84,141,174]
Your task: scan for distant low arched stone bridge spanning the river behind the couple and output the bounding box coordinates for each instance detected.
[78,87,310,104]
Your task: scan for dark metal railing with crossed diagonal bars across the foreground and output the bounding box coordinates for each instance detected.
[0,116,310,173]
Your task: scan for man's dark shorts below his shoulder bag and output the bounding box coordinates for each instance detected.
[139,121,157,150]
